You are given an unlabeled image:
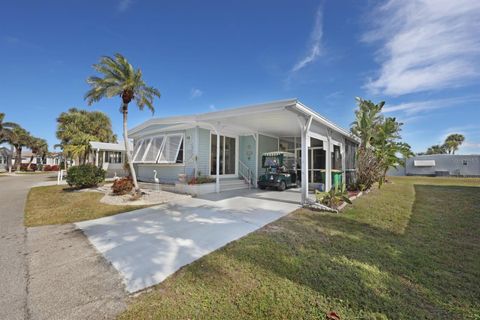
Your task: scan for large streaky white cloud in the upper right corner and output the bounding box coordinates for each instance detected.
[363,0,480,96]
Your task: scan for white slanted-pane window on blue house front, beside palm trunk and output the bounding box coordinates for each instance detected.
[133,134,184,163]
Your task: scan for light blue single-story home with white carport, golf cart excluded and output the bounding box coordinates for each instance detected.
[129,99,358,202]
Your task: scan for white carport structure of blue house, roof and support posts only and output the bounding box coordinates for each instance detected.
[129,99,357,203]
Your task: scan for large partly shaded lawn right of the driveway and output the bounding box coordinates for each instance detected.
[119,177,480,319]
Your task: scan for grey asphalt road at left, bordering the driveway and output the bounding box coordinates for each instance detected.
[0,174,127,320]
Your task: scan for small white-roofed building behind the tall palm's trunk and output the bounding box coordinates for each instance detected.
[88,141,133,178]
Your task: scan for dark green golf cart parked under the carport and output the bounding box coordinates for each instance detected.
[257,152,297,191]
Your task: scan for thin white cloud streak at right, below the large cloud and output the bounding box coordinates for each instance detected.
[382,96,480,115]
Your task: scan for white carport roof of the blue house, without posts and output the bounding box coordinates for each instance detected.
[129,99,358,141]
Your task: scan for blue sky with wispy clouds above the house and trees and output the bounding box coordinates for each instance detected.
[0,0,480,153]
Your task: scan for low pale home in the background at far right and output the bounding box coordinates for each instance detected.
[387,154,480,177]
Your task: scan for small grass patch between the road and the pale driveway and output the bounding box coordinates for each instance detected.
[25,186,144,227]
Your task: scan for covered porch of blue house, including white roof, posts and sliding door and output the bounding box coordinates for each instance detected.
[133,99,357,203]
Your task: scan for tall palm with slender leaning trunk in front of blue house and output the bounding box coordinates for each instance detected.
[85,53,160,194]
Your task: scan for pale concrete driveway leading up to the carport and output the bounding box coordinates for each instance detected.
[76,190,299,292]
